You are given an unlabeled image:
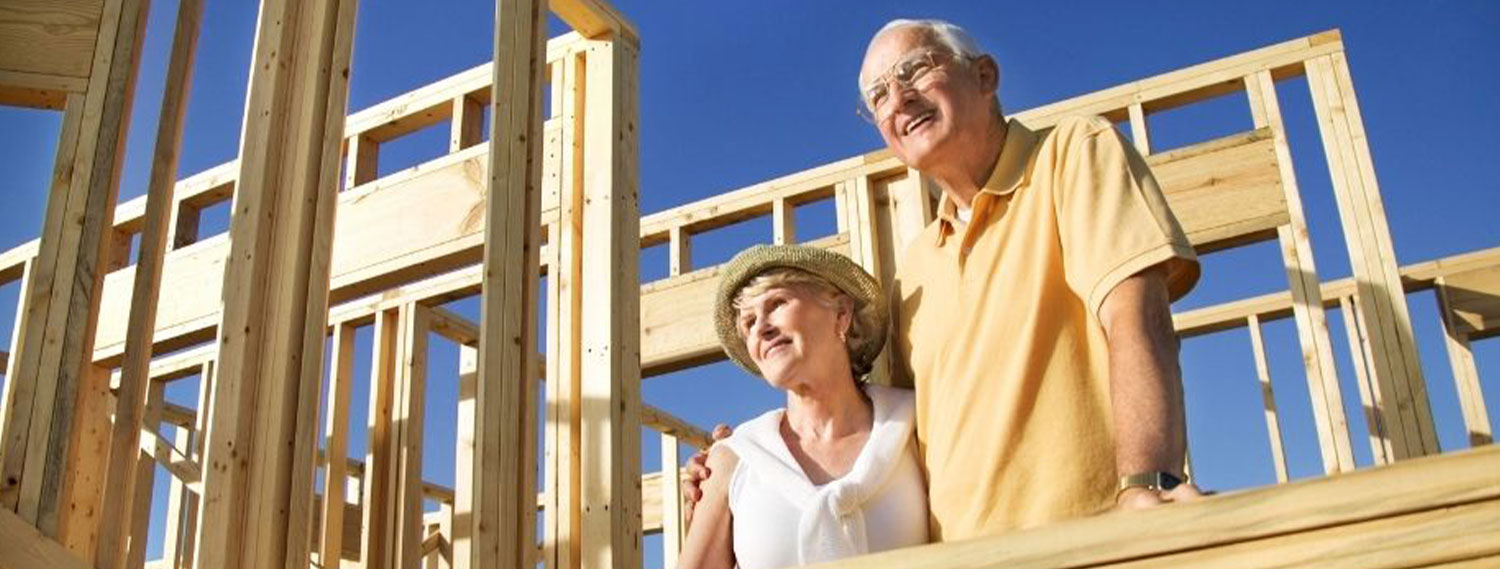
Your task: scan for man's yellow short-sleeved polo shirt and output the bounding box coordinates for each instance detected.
[896,117,1199,540]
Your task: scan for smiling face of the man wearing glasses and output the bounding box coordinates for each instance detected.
[860,27,996,170]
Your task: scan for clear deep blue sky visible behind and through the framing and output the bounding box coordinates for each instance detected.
[0,0,1500,566]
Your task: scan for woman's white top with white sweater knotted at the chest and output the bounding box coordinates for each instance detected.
[722,386,927,569]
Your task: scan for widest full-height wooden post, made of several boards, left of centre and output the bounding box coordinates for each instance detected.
[195,0,357,569]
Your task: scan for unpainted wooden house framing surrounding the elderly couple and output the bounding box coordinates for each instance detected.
[0,0,1500,569]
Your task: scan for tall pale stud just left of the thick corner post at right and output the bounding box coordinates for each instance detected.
[1245,71,1355,474]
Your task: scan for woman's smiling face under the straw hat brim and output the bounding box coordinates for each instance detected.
[737,285,851,389]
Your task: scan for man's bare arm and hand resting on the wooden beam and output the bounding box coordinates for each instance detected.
[1100,264,1200,509]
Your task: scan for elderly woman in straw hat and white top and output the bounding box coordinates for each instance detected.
[678,246,927,569]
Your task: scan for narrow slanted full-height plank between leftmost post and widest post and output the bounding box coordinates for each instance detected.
[95,0,203,569]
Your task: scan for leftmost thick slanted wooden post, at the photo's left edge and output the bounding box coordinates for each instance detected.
[0,0,147,558]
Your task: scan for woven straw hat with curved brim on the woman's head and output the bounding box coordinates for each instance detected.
[714,245,890,375]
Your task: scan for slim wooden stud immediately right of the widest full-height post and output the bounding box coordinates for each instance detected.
[318,324,354,567]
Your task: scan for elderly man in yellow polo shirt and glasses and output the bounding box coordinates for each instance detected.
[687,20,1199,540]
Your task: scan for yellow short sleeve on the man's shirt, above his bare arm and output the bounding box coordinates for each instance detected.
[1053,117,1199,318]
